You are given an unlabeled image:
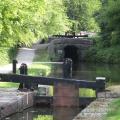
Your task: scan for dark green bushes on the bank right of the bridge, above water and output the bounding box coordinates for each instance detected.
[85,46,120,63]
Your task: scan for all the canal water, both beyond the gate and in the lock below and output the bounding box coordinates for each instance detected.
[5,63,120,120]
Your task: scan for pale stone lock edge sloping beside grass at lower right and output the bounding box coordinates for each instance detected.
[73,86,120,120]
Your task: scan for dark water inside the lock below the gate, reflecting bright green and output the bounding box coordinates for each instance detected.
[5,107,80,120]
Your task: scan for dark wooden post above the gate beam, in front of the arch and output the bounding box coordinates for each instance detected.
[63,58,72,78]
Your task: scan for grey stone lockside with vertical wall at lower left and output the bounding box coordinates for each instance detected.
[0,88,34,120]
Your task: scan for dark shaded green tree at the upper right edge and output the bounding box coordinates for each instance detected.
[98,0,120,47]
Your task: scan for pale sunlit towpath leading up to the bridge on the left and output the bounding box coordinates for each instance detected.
[0,43,49,73]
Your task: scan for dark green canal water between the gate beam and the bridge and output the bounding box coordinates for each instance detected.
[51,63,120,84]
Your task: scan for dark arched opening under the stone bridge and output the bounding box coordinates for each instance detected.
[64,45,80,64]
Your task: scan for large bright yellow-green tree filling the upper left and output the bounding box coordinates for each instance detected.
[0,0,69,46]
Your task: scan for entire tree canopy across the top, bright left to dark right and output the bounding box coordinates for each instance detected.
[0,0,120,46]
